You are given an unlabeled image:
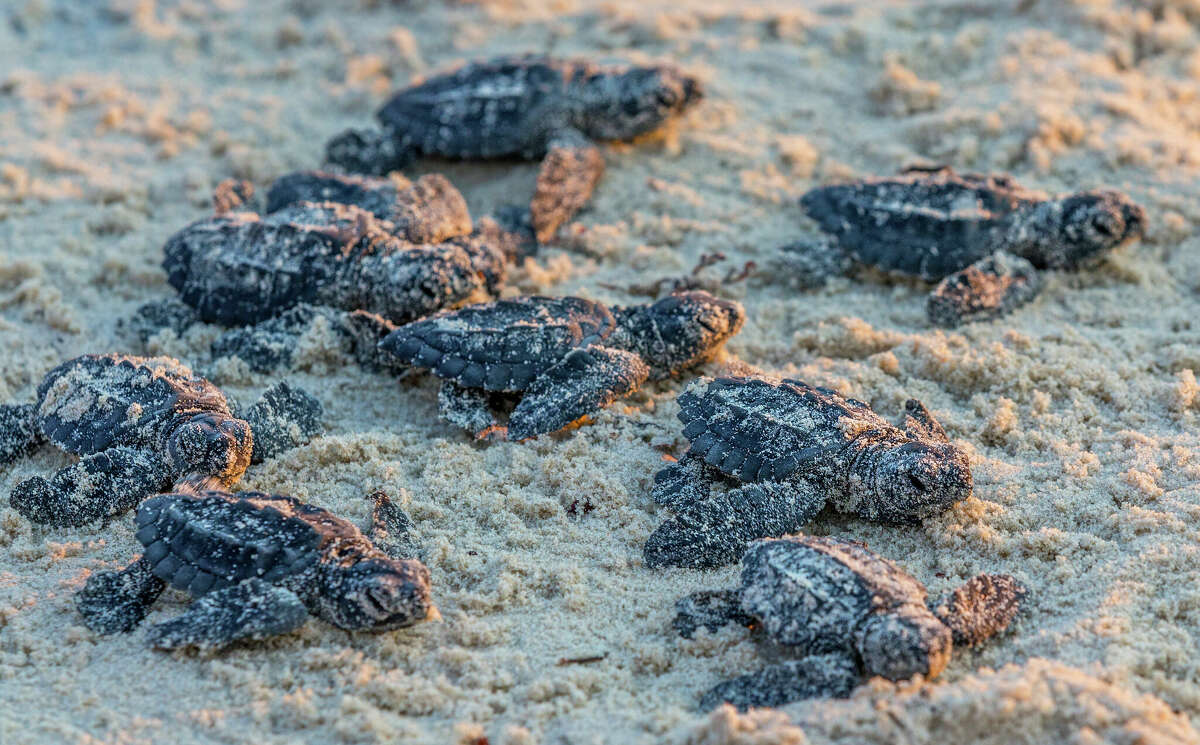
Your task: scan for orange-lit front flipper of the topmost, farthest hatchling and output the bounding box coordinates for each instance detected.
[529,130,604,244]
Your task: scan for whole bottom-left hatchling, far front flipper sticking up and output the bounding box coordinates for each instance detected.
[76,491,437,649]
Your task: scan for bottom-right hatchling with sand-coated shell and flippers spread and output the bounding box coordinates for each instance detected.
[673,536,1026,711]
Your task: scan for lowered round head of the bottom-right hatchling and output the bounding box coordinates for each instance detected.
[854,605,953,680]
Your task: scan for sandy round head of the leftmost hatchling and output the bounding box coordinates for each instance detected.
[167,414,254,488]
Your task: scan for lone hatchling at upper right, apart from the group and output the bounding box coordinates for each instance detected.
[784,168,1146,326]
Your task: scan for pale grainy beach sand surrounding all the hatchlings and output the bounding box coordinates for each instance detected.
[0,0,1200,745]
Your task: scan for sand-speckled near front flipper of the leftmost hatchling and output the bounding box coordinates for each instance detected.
[8,447,170,528]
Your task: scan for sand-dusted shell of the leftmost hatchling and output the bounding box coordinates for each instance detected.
[37,354,226,455]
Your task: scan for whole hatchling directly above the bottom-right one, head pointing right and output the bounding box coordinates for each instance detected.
[644,377,972,566]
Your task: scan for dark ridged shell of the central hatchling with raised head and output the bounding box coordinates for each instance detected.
[380,296,616,391]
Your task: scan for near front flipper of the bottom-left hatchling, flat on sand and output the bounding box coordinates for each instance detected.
[149,578,308,649]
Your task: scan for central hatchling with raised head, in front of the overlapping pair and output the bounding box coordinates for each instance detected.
[380,292,745,440]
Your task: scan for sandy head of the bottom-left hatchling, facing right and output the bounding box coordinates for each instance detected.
[323,558,437,631]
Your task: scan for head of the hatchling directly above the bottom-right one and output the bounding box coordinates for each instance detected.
[858,440,973,523]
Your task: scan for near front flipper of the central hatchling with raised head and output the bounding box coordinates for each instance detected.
[509,346,650,440]
